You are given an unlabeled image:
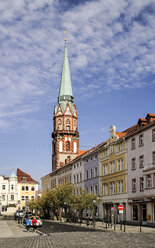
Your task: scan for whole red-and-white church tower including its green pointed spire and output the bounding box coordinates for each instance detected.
[52,38,79,171]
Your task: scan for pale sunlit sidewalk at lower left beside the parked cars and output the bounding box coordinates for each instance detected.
[0,220,38,238]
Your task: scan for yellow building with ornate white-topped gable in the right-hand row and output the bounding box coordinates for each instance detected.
[100,126,127,221]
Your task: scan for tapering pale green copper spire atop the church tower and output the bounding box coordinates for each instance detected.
[58,37,74,102]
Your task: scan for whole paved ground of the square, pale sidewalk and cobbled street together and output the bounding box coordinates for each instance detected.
[0,221,155,248]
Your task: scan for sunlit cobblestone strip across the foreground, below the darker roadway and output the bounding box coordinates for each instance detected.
[0,232,155,248]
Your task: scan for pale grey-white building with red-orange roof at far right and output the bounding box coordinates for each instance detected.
[126,114,155,225]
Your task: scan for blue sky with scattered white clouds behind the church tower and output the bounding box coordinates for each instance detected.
[0,0,155,185]
